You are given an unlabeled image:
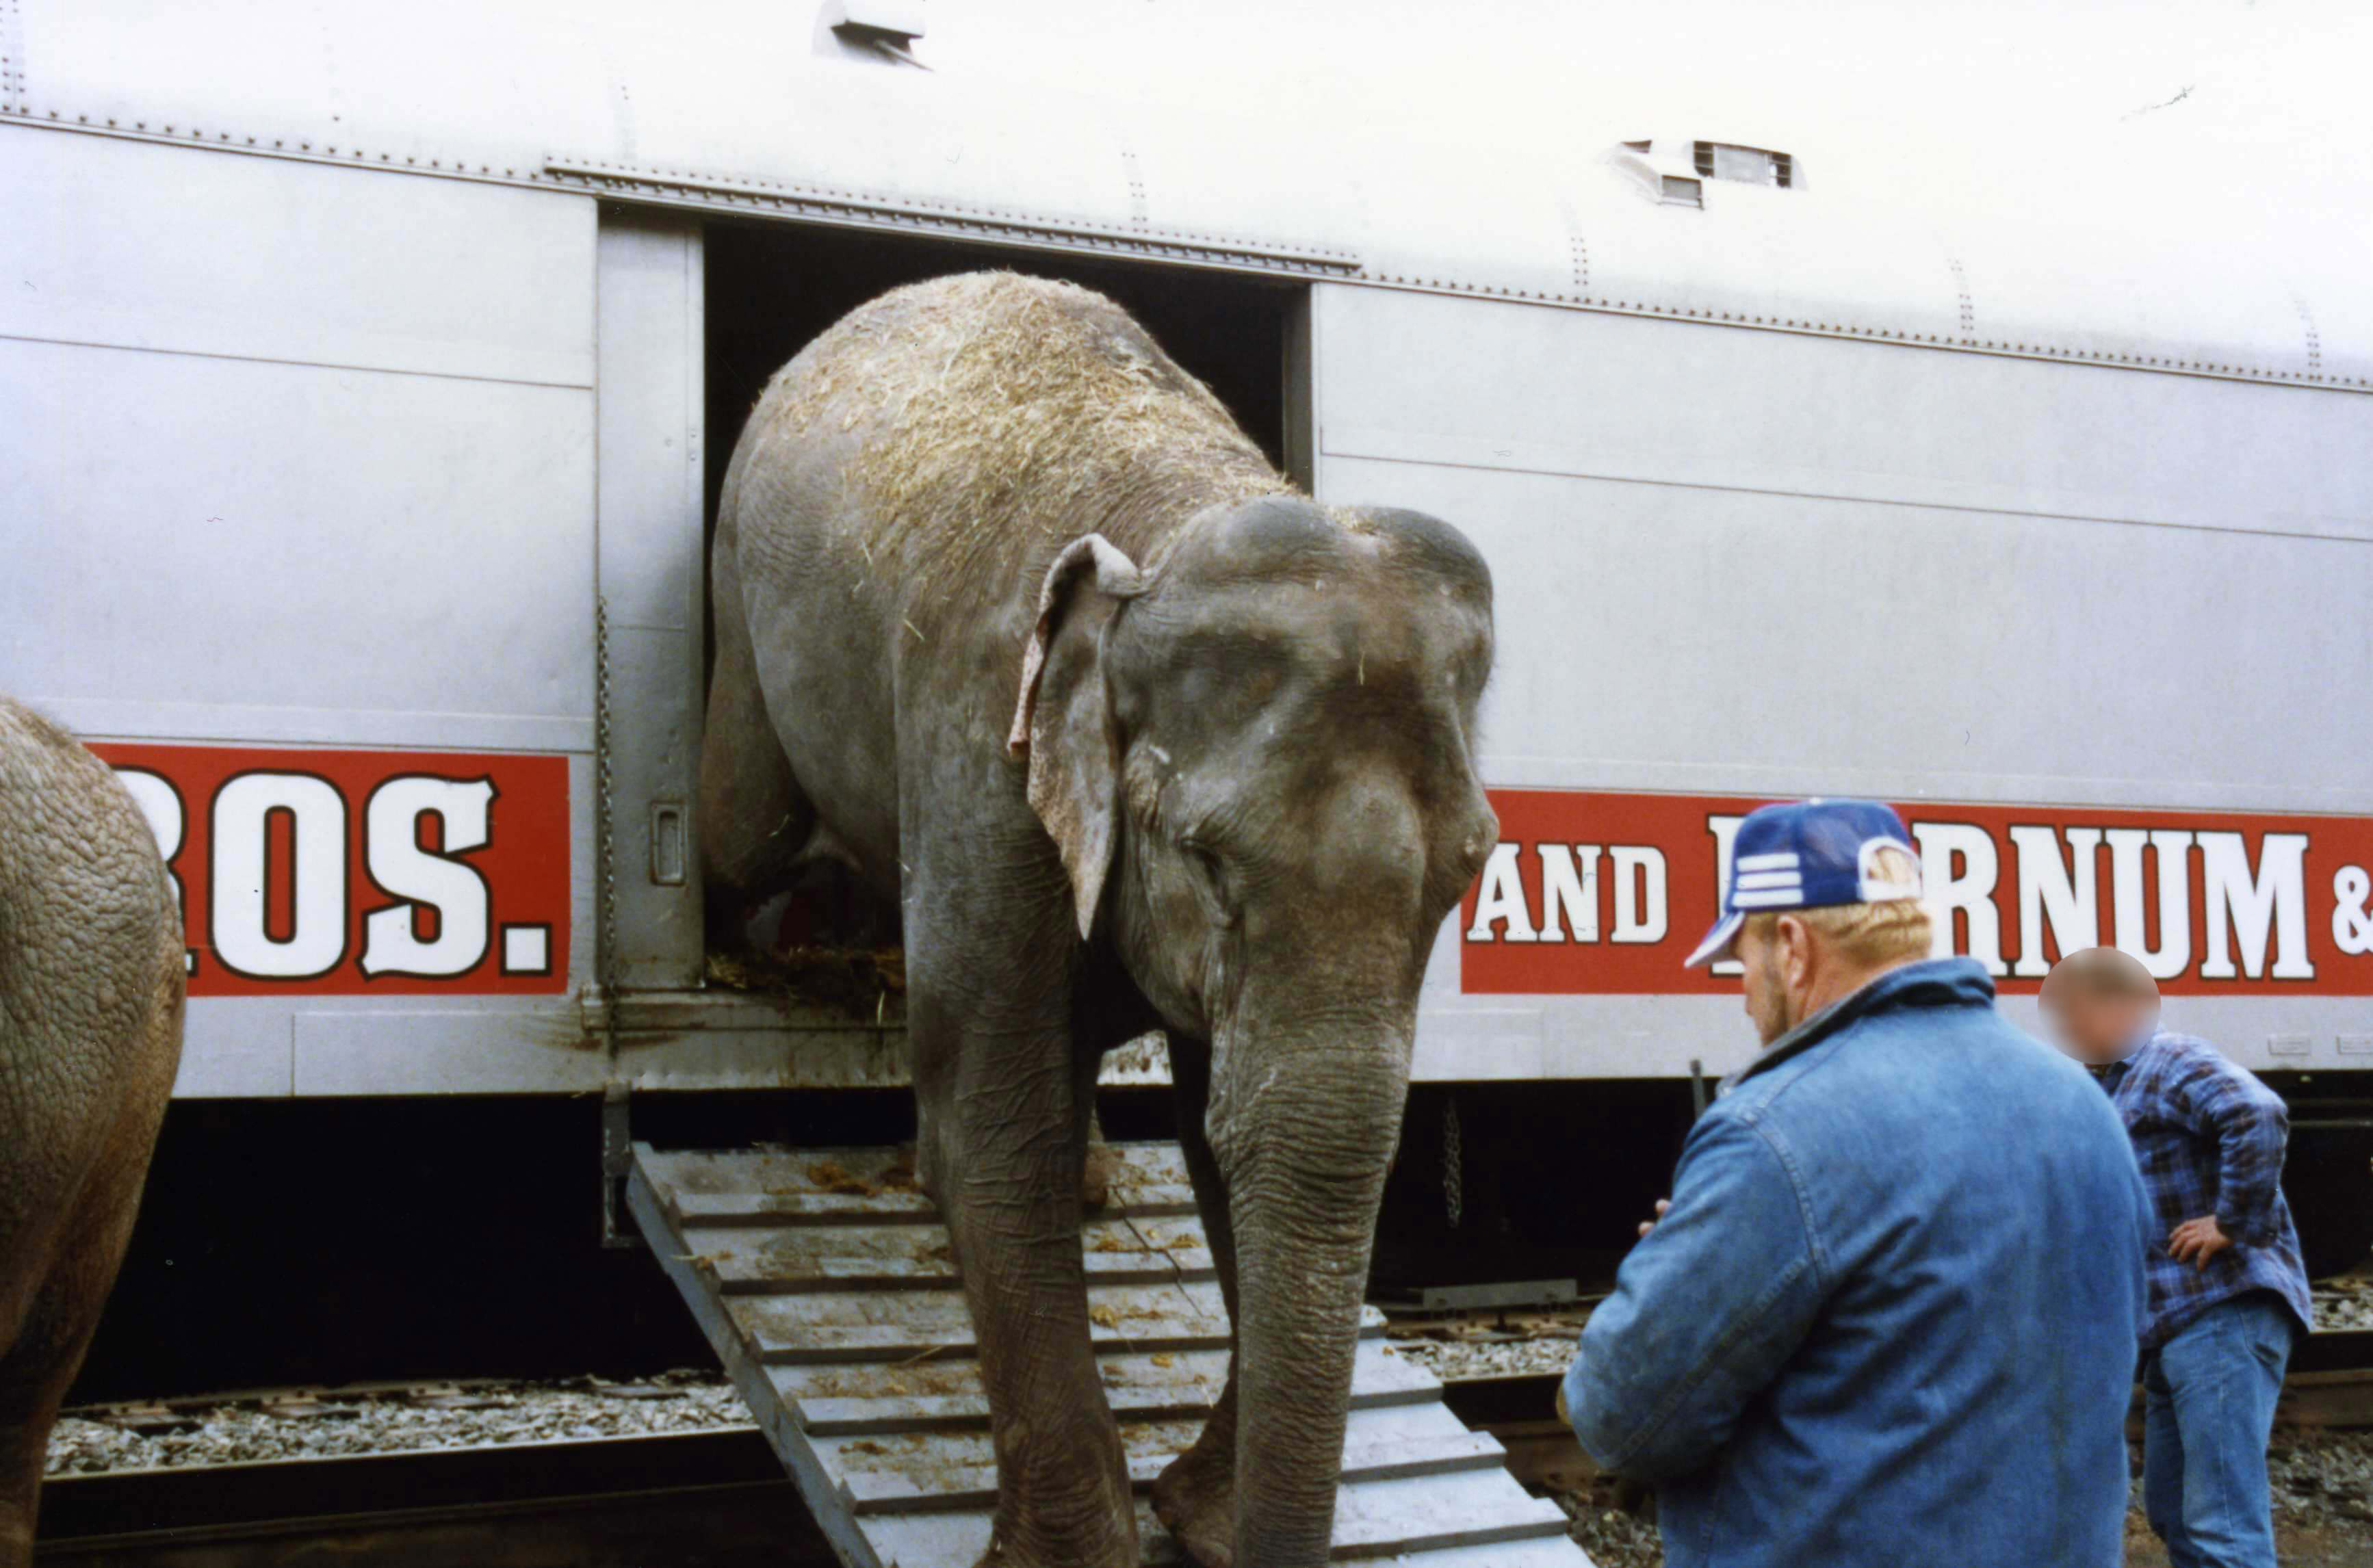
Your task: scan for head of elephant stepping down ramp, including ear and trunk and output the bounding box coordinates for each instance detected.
[1013,496,1497,1563]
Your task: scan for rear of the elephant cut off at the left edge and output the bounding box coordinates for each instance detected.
[0,697,183,1568]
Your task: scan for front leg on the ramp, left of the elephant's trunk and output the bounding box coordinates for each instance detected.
[907,868,1139,1568]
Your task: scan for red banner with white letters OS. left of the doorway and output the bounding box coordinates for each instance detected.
[90,742,569,996]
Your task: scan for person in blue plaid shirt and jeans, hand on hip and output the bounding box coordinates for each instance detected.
[2043,947,2311,1568]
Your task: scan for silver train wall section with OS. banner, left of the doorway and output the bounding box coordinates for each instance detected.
[0,131,600,1096]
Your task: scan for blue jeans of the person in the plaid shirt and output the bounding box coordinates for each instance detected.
[2143,1290,2297,1568]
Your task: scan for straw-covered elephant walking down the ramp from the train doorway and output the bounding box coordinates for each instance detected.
[698,273,1497,1568]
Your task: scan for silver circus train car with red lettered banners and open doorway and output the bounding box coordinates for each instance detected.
[0,0,2373,1138]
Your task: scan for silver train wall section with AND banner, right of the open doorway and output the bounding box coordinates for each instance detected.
[1312,285,2373,1077]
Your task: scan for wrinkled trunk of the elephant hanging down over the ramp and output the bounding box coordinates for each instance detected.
[1213,1020,1410,1568]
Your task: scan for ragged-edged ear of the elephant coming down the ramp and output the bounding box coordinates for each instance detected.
[1006,534,1144,937]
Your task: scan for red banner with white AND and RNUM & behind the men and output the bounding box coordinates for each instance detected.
[1460,790,2373,996]
